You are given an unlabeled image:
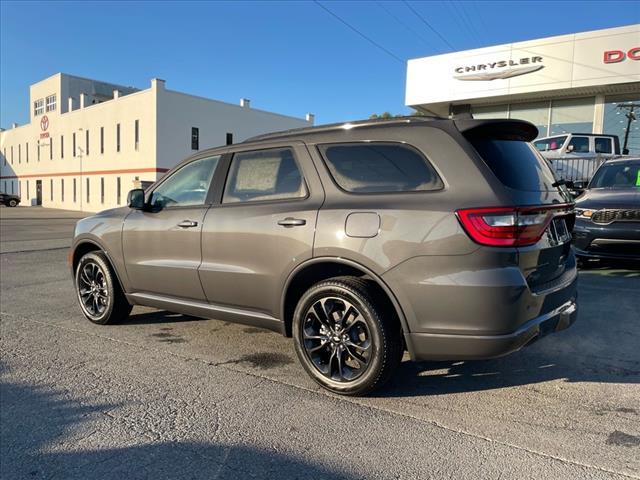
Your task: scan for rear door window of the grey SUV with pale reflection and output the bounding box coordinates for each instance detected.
[222,148,307,203]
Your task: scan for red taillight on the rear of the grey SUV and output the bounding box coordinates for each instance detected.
[456,204,572,247]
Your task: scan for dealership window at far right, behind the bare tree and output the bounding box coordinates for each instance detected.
[603,93,640,155]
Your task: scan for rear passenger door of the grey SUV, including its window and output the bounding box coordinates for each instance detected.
[200,142,324,317]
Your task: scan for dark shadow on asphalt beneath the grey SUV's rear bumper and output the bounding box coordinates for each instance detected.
[374,306,640,397]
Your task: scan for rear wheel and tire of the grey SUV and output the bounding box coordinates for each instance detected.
[293,277,404,395]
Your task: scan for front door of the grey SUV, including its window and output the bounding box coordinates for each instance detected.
[122,155,221,300]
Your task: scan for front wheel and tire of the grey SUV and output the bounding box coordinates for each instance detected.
[74,251,132,325]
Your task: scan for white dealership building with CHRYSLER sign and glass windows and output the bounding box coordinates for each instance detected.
[405,25,640,155]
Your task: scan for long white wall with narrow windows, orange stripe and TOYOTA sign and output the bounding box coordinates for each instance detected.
[0,85,156,212]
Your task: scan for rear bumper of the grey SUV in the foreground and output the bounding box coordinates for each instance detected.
[383,249,578,360]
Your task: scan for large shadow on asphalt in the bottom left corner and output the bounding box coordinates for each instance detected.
[0,364,351,480]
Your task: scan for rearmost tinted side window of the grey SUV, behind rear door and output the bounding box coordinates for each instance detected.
[319,142,443,193]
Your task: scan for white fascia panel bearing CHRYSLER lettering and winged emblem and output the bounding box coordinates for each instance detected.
[405,24,640,108]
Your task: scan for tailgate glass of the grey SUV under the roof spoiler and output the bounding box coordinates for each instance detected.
[470,138,556,192]
